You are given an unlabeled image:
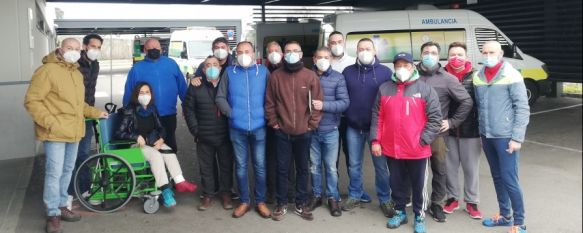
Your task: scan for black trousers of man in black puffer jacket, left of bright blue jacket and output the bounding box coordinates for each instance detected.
[196,141,233,197]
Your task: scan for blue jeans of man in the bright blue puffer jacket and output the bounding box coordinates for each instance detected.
[230,128,266,204]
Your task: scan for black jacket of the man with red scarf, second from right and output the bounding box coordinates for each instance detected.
[449,70,480,138]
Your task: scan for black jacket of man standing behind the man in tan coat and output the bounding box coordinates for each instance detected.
[78,51,99,106]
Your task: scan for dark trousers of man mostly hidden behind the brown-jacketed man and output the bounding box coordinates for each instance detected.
[265,127,296,198]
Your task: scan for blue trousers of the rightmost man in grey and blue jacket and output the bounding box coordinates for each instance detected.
[482,135,524,225]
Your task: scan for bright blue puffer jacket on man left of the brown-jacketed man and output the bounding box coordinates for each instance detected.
[216,65,269,131]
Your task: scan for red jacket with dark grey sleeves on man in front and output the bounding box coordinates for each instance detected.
[370,73,442,159]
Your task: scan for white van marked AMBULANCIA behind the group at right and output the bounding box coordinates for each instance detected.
[321,10,550,104]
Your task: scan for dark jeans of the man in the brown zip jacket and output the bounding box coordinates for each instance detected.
[275,130,312,205]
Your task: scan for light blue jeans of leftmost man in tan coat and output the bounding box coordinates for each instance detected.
[43,141,79,216]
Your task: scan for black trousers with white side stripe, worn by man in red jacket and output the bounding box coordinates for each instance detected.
[390,155,429,217]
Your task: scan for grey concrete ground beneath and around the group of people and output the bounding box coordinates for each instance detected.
[0,69,582,233]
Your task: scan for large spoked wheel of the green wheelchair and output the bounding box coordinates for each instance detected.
[74,154,136,213]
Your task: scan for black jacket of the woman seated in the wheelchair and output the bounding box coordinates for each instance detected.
[115,105,166,146]
